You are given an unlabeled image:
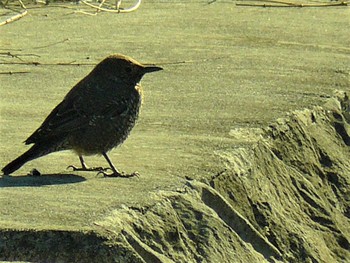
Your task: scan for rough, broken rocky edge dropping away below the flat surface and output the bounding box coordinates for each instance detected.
[0,92,350,262]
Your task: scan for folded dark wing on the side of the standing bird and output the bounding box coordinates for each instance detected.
[25,79,128,144]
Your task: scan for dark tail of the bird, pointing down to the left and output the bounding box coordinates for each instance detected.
[1,144,48,175]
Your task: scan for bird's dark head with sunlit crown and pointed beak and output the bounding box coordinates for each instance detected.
[94,54,162,84]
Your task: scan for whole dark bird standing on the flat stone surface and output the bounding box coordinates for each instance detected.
[2,54,162,177]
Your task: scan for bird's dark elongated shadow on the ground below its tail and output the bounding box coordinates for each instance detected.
[0,174,86,188]
